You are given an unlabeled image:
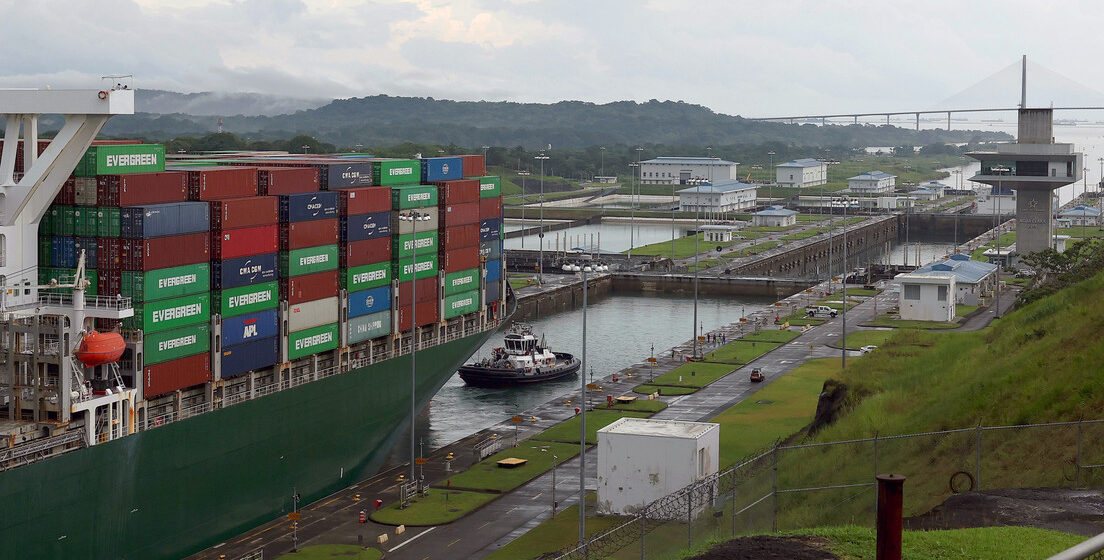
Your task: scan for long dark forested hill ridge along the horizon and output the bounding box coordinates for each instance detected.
[104,94,1008,148]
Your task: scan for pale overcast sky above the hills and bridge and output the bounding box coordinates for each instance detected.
[0,0,1104,116]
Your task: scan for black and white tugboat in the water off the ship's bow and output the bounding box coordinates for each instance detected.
[459,323,580,387]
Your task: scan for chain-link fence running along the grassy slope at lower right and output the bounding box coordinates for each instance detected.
[554,420,1104,560]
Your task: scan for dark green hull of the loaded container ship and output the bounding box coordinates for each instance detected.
[0,331,492,560]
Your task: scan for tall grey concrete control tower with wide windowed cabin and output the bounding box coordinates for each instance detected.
[967,104,1084,255]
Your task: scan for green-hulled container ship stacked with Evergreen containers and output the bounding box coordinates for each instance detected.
[0,91,509,559]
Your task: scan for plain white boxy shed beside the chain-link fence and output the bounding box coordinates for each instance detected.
[597,418,721,514]
